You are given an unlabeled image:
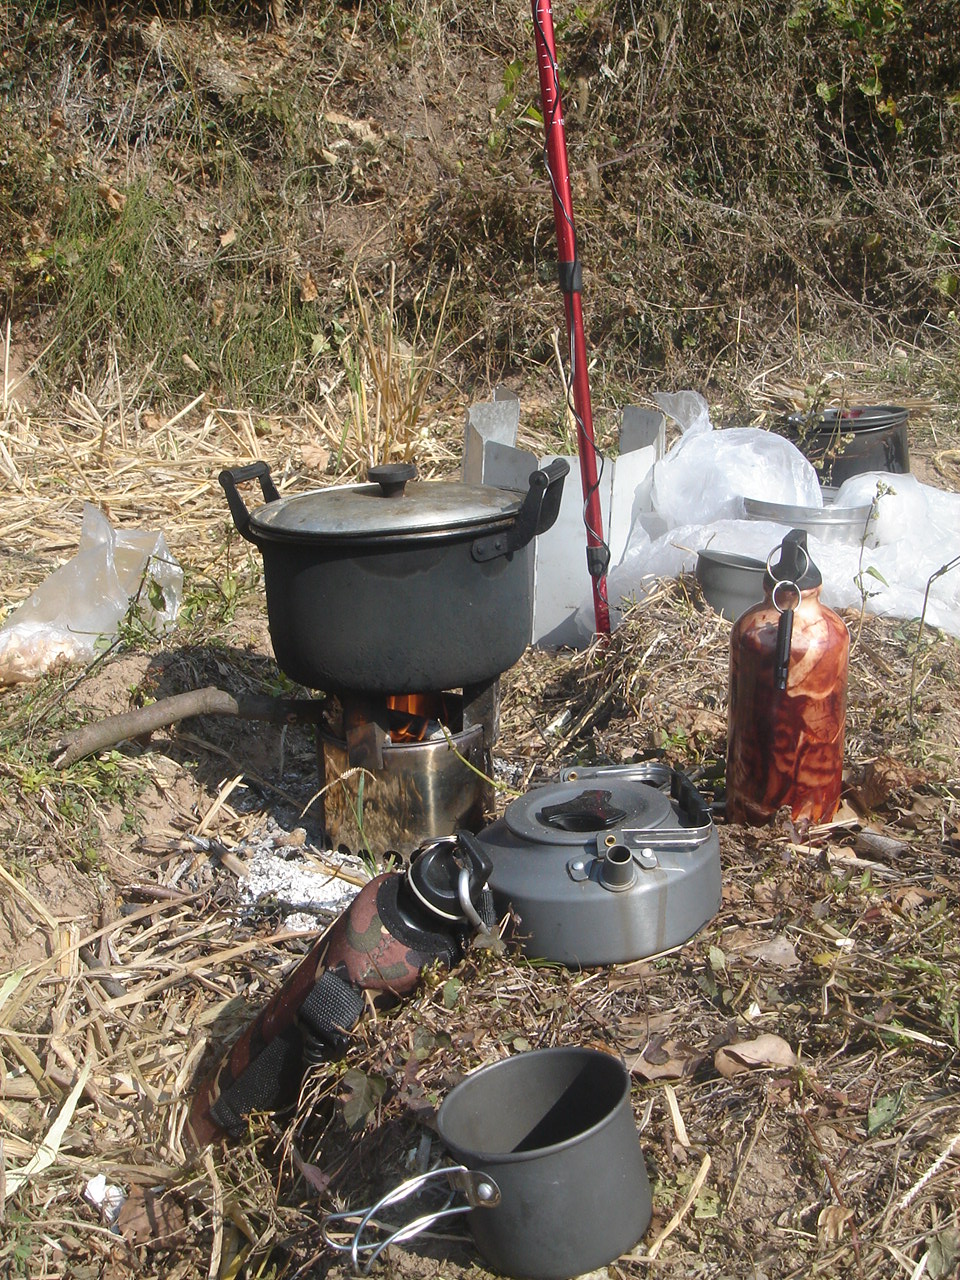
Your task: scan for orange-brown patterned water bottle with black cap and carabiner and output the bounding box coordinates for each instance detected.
[727,529,850,824]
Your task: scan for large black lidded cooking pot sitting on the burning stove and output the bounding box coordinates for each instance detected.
[219,458,570,694]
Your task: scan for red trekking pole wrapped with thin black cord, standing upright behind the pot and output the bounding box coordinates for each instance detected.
[532,0,611,635]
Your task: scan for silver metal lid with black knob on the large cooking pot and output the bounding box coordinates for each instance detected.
[250,463,524,541]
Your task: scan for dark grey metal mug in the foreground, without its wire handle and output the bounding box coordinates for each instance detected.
[436,1047,652,1280]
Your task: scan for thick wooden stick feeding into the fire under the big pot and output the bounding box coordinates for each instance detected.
[54,685,323,769]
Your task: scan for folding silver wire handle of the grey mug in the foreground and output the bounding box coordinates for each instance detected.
[320,1165,500,1275]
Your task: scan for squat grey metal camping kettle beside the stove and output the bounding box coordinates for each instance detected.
[477,764,721,968]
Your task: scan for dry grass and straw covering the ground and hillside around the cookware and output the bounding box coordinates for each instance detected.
[0,0,960,1280]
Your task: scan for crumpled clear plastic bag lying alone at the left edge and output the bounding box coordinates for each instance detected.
[0,503,183,685]
